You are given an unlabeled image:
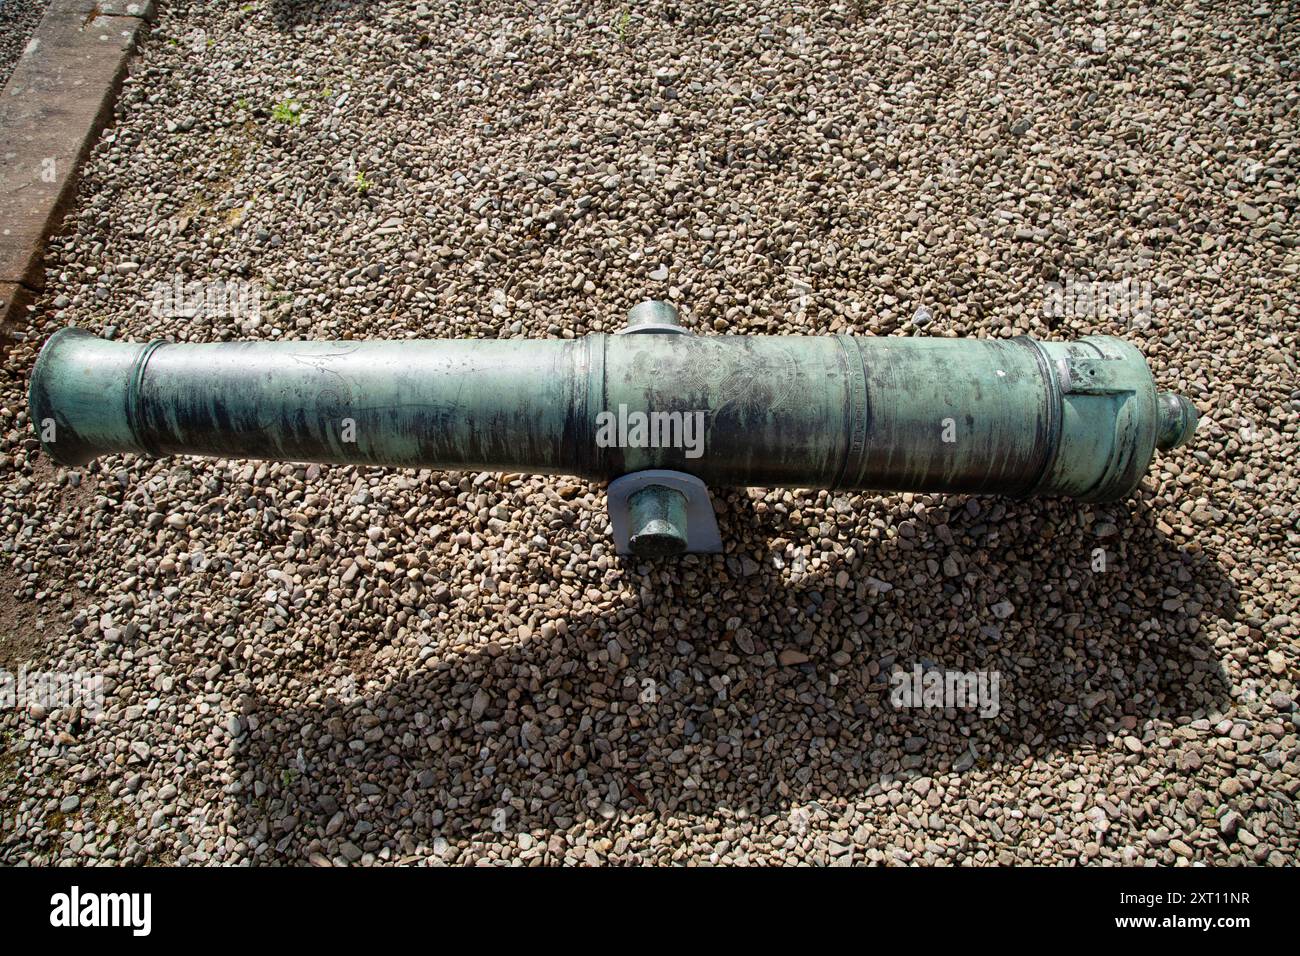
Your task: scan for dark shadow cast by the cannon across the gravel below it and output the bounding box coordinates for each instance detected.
[234,493,1238,862]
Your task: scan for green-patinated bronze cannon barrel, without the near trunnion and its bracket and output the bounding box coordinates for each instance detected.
[30,316,1196,501]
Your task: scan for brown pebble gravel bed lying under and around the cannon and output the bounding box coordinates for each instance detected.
[0,0,1300,865]
